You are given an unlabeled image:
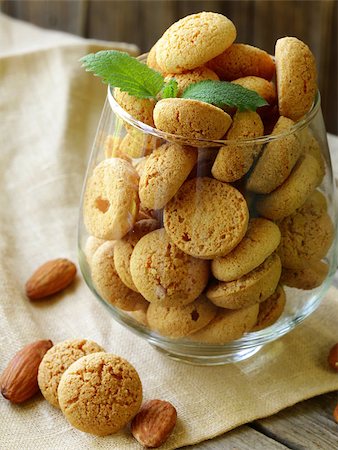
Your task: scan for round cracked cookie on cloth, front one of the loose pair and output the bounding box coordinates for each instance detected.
[58,353,142,436]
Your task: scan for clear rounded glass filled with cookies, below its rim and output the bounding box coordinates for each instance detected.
[78,67,337,365]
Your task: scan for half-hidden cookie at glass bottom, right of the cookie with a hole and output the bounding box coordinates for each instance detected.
[189,304,259,344]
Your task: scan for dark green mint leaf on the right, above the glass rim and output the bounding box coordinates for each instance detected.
[181,80,268,111]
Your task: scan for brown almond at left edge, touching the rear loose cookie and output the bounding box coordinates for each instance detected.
[0,340,53,403]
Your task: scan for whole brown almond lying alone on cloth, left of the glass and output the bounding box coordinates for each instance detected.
[25,258,76,300]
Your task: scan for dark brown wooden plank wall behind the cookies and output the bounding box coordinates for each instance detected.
[0,0,338,134]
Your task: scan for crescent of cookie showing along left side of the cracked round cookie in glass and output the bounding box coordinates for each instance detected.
[114,219,159,292]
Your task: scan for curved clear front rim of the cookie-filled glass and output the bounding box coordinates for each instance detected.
[107,54,321,147]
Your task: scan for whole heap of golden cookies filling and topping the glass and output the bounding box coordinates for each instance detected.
[83,12,334,344]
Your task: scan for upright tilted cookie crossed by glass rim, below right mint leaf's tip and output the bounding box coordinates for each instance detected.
[211,111,264,183]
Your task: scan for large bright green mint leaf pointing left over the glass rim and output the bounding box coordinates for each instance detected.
[80,50,164,98]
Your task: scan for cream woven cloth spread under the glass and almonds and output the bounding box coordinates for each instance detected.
[0,15,338,450]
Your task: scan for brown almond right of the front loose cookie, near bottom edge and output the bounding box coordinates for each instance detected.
[131,400,177,448]
